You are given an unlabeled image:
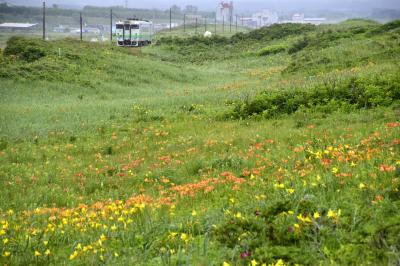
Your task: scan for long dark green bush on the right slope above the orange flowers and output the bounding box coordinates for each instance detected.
[227,73,400,118]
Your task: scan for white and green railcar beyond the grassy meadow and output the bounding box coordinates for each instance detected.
[115,19,153,46]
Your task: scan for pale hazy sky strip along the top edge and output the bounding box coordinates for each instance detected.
[5,0,400,10]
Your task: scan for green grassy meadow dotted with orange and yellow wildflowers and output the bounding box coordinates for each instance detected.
[0,20,400,266]
